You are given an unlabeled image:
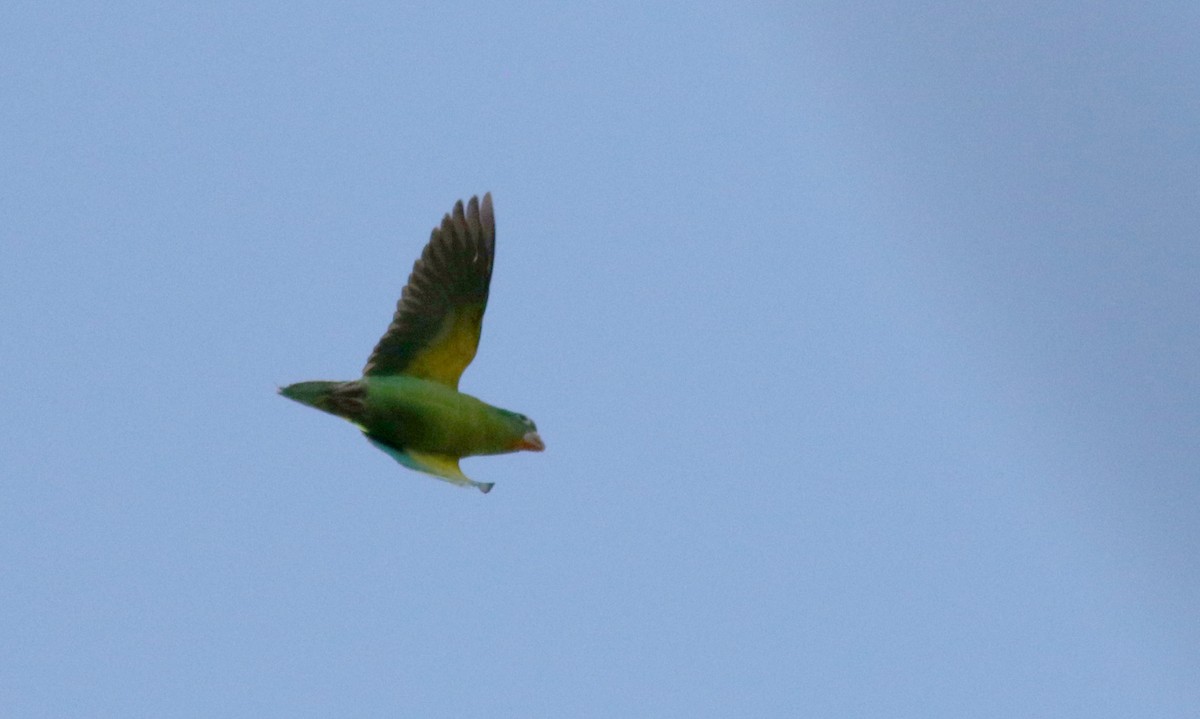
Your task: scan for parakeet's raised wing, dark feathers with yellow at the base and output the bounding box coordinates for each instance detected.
[362,192,496,389]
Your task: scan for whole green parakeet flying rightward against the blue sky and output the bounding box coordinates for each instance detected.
[280,193,546,492]
